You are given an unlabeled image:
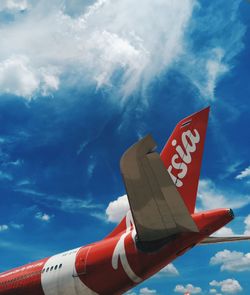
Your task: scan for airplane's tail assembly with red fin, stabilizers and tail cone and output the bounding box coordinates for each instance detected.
[107,108,250,247]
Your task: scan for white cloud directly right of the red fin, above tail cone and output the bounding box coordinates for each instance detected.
[198,179,250,210]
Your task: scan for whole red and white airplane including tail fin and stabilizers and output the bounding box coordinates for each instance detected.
[0,107,250,295]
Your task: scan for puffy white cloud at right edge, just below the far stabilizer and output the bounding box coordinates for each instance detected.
[210,250,250,272]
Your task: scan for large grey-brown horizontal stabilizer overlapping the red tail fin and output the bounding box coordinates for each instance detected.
[120,135,199,242]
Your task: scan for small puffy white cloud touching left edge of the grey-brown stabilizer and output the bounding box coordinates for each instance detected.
[106,195,129,223]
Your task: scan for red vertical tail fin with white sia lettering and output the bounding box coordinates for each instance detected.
[161,107,209,213]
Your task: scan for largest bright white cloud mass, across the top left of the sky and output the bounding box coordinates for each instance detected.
[0,0,195,97]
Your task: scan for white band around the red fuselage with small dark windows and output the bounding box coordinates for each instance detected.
[41,248,97,295]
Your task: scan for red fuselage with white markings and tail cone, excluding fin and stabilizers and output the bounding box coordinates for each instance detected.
[0,209,233,295]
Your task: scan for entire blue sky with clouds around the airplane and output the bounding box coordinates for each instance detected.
[0,0,250,295]
